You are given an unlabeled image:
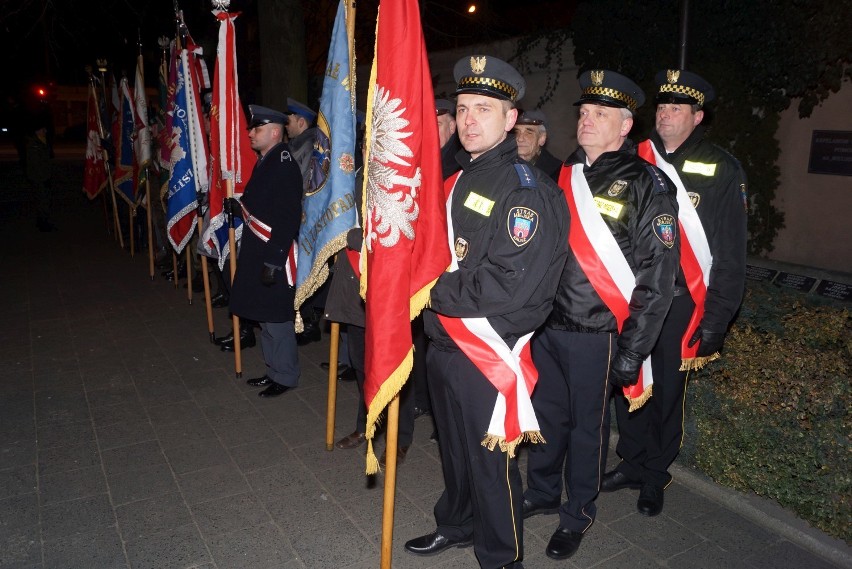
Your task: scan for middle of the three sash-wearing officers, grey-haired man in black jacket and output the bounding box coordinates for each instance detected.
[524,70,678,559]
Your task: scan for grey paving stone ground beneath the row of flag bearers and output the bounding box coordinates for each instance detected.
[0,156,852,569]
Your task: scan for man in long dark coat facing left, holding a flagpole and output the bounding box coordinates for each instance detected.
[226,105,302,397]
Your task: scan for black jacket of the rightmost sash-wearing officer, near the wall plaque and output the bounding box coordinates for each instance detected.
[651,126,748,332]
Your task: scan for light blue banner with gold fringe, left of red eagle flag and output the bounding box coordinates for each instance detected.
[296,0,357,308]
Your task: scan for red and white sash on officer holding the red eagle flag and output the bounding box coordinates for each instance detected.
[438,173,544,457]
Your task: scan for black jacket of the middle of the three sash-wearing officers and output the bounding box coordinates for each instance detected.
[548,140,680,356]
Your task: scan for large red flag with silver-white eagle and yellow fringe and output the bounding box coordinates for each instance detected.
[361,0,450,474]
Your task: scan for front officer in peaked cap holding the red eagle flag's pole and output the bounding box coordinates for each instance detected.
[405,56,568,569]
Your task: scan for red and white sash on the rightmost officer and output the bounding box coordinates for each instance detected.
[639,140,720,371]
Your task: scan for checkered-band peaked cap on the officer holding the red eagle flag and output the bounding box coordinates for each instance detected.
[453,55,526,103]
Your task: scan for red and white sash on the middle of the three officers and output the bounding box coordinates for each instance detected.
[559,164,654,411]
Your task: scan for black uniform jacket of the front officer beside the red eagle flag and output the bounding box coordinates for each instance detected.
[425,137,569,348]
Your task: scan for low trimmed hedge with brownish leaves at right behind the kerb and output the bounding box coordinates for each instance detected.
[681,281,852,543]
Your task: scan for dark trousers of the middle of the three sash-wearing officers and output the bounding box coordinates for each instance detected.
[524,328,616,532]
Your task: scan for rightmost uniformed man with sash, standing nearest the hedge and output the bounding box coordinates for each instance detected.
[601,69,747,516]
